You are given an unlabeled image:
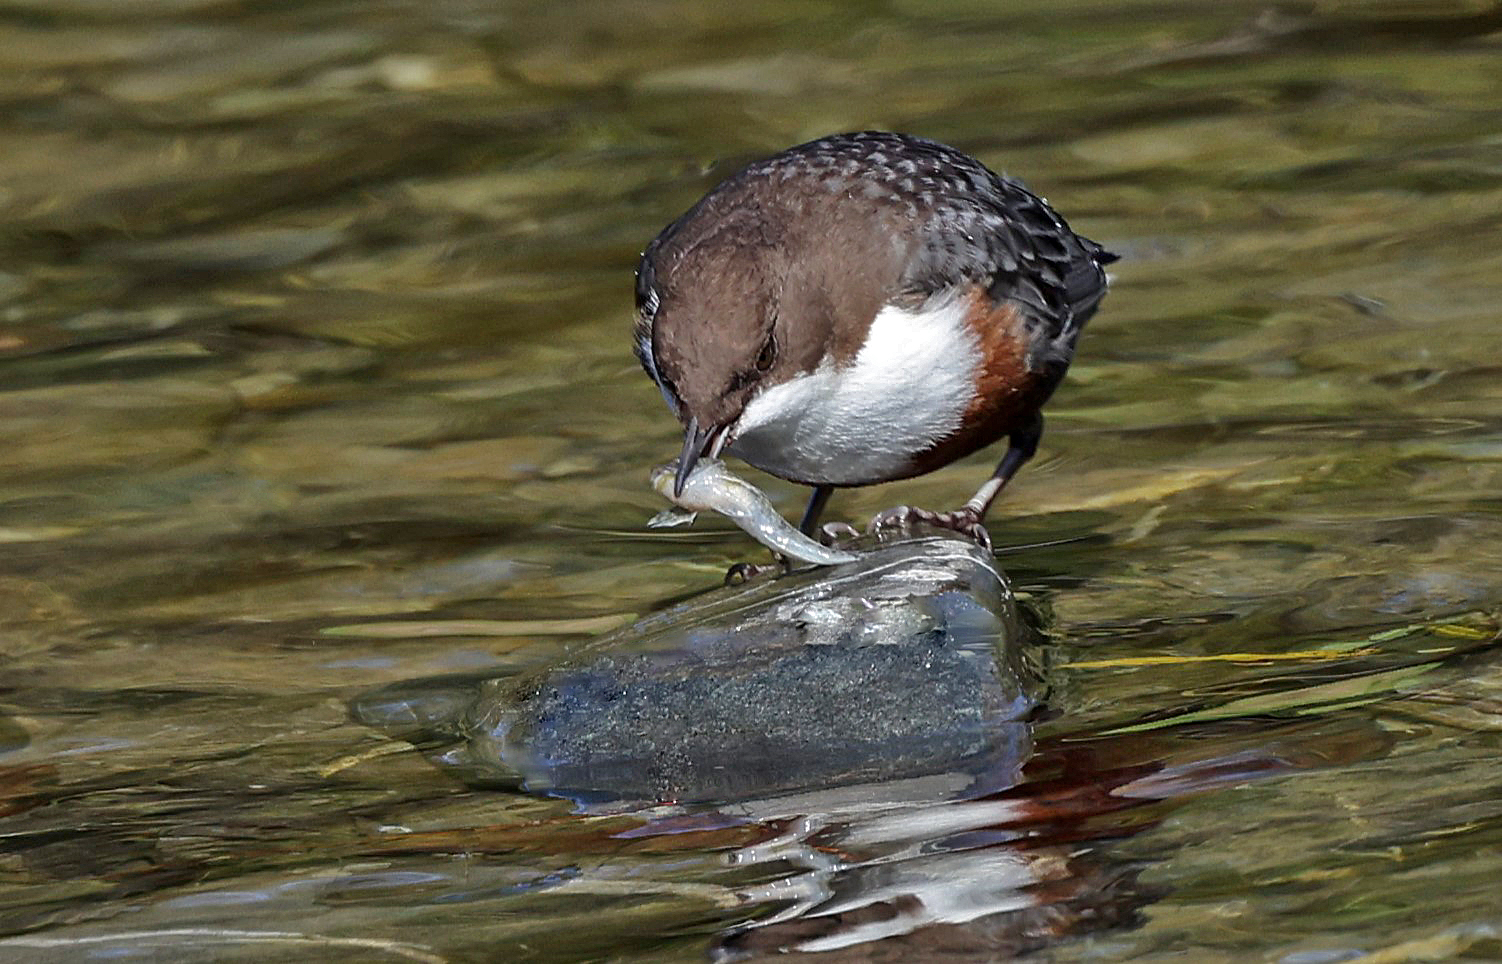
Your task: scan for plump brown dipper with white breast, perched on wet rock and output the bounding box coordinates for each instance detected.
[635,131,1116,547]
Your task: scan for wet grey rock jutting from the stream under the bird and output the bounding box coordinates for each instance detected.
[356,535,1038,805]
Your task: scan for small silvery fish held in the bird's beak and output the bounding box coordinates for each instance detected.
[647,458,859,566]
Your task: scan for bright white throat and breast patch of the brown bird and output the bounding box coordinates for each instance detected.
[728,296,981,485]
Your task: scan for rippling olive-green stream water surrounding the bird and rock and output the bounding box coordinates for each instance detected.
[0,0,1502,964]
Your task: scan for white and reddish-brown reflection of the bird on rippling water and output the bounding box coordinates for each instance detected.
[716,708,1386,961]
